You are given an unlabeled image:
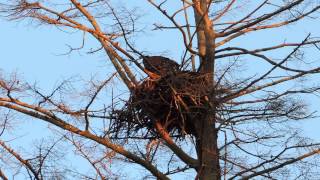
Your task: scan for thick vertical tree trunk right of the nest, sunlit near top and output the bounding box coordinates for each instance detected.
[193,0,220,180]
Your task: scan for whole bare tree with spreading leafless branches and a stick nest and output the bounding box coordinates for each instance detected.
[0,0,320,180]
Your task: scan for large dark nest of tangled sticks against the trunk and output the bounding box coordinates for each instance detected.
[113,71,225,137]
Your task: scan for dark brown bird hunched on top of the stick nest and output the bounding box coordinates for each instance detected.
[143,56,180,79]
